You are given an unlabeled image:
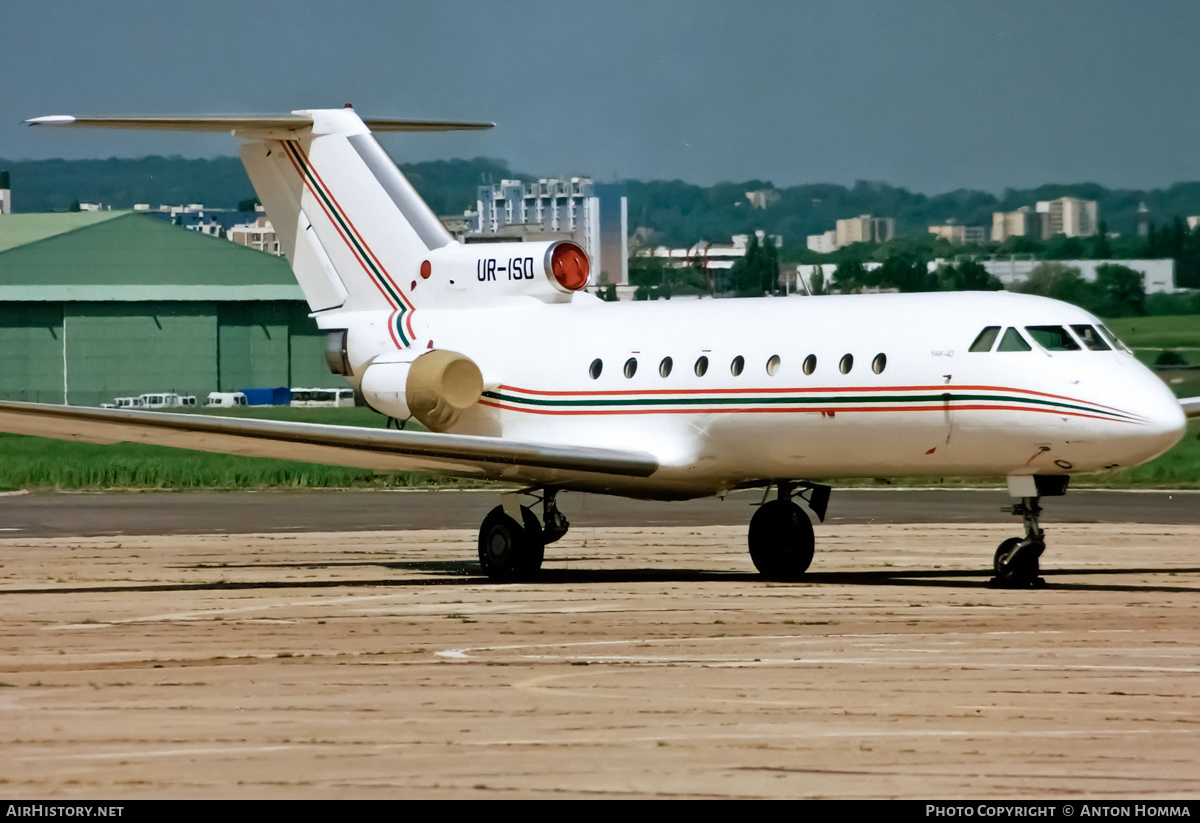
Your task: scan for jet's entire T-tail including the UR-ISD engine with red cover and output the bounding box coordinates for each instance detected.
[29,108,589,349]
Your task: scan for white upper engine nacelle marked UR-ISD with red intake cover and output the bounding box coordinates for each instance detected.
[420,240,592,300]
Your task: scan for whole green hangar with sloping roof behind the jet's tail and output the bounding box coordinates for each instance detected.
[0,211,341,406]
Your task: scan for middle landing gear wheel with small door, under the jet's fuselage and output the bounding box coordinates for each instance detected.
[749,480,830,581]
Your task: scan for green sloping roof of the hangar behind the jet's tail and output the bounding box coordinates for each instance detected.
[0,211,304,301]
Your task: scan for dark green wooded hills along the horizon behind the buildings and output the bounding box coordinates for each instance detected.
[11,156,1200,259]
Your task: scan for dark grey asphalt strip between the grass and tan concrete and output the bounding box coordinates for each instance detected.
[0,487,1200,536]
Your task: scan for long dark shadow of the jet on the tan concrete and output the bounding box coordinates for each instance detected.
[11,558,1200,595]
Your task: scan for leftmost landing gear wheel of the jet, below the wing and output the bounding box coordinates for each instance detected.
[479,488,570,581]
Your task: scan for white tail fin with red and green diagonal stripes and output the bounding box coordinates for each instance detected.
[241,109,455,346]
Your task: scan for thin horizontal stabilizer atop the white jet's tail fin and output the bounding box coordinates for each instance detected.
[25,114,496,134]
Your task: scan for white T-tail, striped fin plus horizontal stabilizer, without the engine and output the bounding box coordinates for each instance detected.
[25,108,501,348]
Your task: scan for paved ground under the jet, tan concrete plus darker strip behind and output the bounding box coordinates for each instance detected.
[0,492,1200,800]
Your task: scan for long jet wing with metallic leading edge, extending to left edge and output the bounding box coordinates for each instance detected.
[0,402,659,482]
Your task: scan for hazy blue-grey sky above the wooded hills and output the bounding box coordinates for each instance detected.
[0,0,1200,193]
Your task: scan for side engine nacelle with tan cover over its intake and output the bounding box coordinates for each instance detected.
[361,349,484,432]
